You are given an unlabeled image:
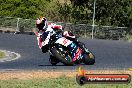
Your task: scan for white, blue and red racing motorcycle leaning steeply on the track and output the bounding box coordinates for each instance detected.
[37,28,95,66]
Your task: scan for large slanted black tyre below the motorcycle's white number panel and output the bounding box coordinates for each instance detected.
[51,47,74,66]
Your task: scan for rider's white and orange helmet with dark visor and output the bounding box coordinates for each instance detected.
[36,17,48,31]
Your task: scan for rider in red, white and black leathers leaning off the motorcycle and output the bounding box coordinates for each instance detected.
[35,17,86,53]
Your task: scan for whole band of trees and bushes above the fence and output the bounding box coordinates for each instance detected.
[0,0,132,28]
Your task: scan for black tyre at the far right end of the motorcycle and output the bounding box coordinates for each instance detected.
[84,53,95,65]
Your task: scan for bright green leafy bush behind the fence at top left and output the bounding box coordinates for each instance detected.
[0,0,51,19]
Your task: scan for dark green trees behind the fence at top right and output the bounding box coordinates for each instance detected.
[71,0,132,27]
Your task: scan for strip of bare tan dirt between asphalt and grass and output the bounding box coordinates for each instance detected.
[0,70,132,80]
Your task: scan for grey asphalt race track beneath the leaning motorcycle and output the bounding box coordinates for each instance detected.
[0,34,132,70]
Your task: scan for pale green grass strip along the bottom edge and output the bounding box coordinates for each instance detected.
[0,76,132,88]
